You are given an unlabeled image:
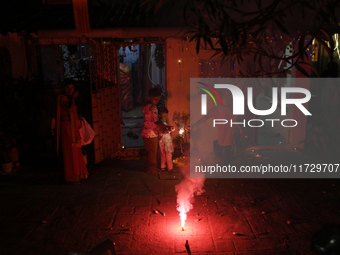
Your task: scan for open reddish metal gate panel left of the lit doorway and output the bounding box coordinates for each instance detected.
[89,40,122,164]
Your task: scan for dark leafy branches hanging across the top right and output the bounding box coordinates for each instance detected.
[145,0,340,76]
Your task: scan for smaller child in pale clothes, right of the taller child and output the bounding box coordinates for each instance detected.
[158,106,174,171]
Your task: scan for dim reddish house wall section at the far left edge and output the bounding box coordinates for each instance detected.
[0,33,27,79]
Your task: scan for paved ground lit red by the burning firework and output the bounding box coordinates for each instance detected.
[0,147,340,255]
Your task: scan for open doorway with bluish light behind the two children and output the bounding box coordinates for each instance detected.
[119,43,166,148]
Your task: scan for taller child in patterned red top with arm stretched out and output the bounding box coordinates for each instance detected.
[141,87,174,174]
